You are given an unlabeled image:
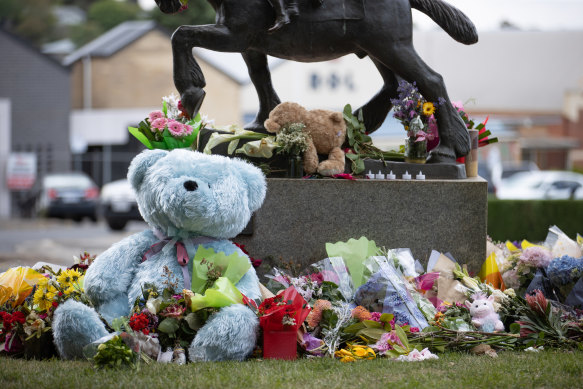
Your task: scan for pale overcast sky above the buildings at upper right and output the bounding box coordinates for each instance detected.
[139,0,583,31]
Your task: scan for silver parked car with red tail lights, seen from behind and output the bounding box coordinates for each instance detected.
[32,172,99,221]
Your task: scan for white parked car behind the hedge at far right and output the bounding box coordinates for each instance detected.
[496,171,583,200]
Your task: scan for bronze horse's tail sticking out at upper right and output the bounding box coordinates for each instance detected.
[409,0,478,45]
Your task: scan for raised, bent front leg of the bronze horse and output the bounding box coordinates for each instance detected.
[172,24,245,117]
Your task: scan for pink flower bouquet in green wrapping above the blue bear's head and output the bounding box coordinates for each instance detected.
[128,95,202,150]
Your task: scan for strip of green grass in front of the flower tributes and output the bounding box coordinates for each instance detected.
[0,351,583,389]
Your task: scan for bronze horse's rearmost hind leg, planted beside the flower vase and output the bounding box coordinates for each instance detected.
[370,44,470,163]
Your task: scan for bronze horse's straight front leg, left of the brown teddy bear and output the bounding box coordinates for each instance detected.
[241,51,281,133]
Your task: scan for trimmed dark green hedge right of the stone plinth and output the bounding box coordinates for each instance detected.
[488,199,583,242]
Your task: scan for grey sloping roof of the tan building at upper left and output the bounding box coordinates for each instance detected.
[63,20,157,66]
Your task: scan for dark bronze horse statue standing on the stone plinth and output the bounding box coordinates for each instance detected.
[155,0,478,162]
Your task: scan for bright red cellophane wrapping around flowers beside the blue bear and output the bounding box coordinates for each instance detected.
[259,286,310,332]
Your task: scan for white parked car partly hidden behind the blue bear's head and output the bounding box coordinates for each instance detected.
[100,179,142,231]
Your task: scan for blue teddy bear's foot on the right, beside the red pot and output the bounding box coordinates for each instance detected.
[188,304,259,362]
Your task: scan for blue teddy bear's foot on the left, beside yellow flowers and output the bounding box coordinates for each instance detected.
[52,300,107,359]
